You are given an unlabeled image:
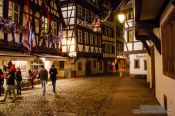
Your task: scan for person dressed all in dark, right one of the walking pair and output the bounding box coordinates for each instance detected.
[49,65,57,93]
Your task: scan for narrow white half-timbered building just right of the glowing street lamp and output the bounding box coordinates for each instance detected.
[122,0,147,76]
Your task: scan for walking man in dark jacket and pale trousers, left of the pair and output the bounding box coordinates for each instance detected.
[39,65,48,95]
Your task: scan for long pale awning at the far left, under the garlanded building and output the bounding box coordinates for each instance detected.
[0,50,33,61]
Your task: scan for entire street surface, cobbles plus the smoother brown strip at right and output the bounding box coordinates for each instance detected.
[0,75,166,116]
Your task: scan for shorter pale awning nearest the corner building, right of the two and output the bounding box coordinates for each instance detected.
[33,54,67,61]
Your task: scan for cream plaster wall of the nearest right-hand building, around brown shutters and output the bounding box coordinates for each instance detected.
[154,5,175,116]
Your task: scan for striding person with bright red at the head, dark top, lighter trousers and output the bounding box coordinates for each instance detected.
[3,63,16,102]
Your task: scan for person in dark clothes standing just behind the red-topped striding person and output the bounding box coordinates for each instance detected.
[16,68,22,95]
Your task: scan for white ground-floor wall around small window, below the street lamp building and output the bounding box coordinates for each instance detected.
[129,54,147,75]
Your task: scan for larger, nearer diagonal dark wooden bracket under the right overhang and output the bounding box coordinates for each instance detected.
[145,29,161,54]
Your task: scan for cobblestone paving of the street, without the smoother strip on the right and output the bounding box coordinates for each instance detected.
[0,76,117,116]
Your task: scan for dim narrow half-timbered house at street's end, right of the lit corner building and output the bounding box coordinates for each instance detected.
[102,0,116,72]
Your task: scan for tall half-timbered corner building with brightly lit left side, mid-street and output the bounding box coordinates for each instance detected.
[61,0,103,76]
